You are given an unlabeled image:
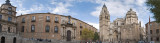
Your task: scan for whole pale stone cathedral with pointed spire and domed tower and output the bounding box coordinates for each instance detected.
[99,5,144,43]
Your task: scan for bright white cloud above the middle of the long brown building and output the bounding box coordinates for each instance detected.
[51,0,75,15]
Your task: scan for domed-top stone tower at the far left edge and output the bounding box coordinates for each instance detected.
[0,0,16,33]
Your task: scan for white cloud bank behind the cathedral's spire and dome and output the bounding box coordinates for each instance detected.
[91,0,149,26]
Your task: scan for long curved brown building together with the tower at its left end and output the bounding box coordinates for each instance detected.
[0,0,97,43]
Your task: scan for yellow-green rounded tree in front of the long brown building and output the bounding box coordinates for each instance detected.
[81,29,94,40]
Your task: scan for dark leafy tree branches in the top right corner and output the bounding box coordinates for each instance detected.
[146,0,160,22]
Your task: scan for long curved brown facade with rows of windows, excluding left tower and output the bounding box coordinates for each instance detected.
[17,13,97,41]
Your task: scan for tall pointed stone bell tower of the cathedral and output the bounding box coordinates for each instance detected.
[99,4,110,41]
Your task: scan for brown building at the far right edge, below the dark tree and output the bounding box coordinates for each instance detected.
[145,21,160,43]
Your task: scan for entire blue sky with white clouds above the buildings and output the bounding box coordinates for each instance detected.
[0,0,154,29]
